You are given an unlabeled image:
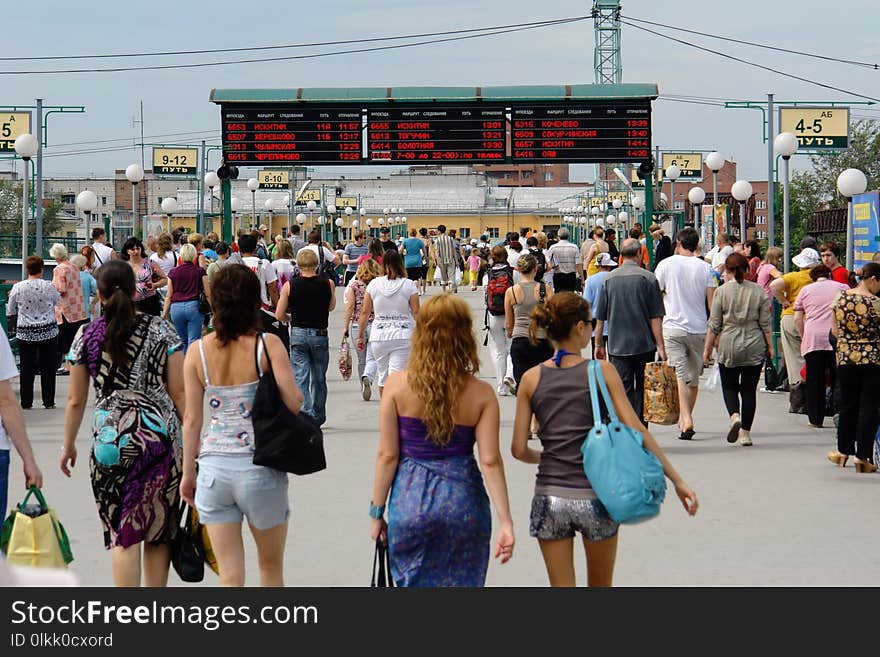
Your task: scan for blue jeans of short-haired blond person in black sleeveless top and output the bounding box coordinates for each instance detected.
[290,326,330,425]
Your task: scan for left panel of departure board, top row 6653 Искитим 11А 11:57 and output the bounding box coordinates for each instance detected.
[221,105,362,165]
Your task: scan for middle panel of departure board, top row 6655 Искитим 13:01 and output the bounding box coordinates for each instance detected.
[367,105,506,164]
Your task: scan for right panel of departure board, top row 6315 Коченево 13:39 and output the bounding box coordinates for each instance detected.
[511,101,651,163]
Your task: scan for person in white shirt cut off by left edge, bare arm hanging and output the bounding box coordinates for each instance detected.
[0,327,43,520]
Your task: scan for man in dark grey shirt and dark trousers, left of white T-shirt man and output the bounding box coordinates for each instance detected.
[593,238,666,423]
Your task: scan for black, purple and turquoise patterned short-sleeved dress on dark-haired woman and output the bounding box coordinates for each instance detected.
[68,313,183,550]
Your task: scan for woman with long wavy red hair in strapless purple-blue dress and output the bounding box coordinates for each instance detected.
[370,294,514,586]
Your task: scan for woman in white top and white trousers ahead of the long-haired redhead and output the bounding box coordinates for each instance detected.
[356,249,419,395]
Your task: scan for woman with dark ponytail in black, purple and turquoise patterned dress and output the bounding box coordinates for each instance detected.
[61,260,184,586]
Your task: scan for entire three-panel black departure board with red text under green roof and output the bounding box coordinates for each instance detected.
[221,100,651,166]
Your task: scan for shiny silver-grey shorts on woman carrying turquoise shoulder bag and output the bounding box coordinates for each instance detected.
[529,494,619,541]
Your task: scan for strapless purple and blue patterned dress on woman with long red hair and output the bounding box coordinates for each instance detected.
[388,417,492,587]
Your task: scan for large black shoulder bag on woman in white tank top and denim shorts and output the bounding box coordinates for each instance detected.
[251,333,327,475]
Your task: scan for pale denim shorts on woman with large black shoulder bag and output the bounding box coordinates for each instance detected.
[195,456,290,529]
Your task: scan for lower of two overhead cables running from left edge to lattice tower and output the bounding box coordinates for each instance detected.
[0,16,591,75]
